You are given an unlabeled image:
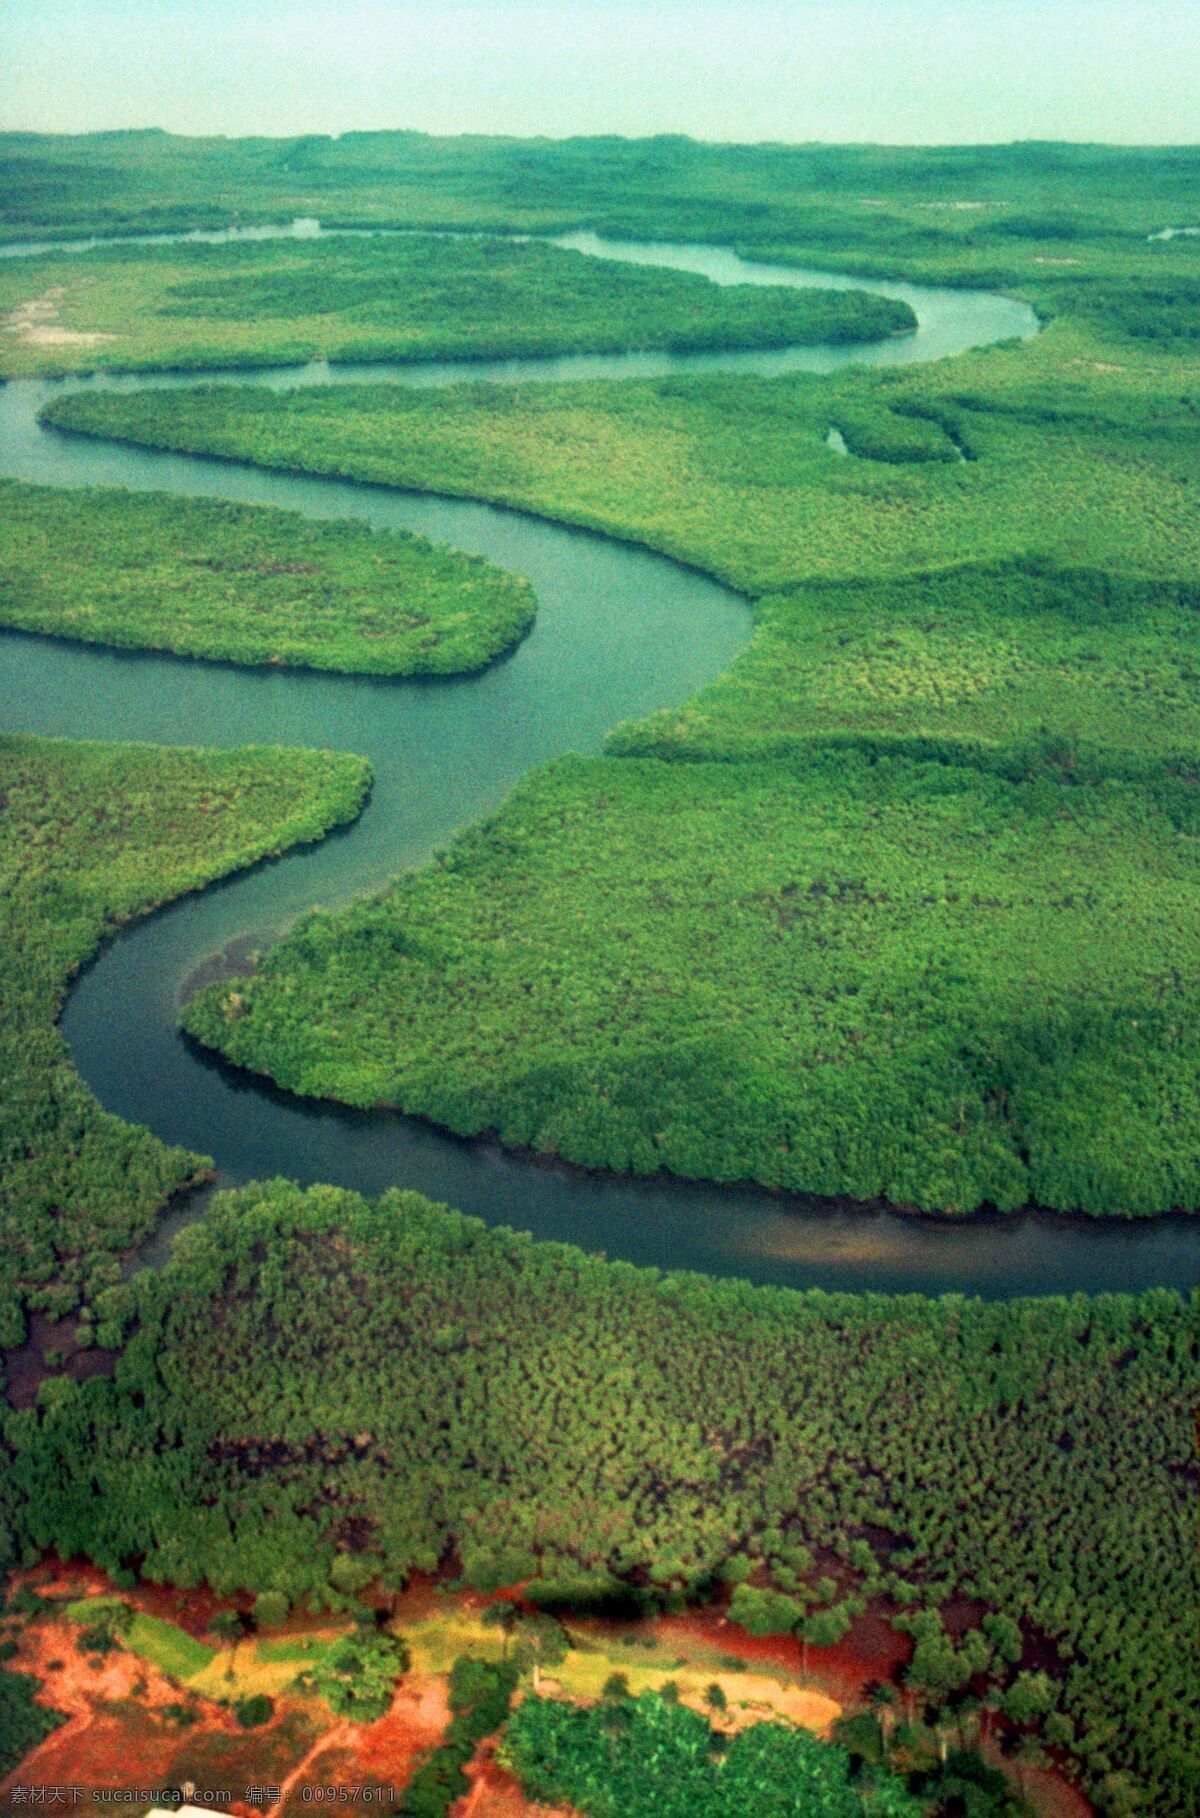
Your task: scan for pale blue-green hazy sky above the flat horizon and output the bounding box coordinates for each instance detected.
[0,0,1200,144]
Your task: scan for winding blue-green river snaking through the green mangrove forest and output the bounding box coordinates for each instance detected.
[0,222,1200,1296]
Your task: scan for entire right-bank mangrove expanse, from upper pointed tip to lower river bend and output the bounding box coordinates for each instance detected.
[51,202,1200,1213]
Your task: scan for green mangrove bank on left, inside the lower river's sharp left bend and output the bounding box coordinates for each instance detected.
[0,738,367,1345]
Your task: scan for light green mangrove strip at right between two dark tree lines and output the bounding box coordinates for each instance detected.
[609,562,1200,773]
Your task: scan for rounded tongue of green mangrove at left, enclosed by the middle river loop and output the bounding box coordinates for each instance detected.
[0,480,535,674]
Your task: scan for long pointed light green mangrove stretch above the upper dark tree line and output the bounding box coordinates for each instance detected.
[47,324,1200,594]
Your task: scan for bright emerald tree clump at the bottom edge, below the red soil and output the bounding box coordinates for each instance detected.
[500,1693,922,1818]
